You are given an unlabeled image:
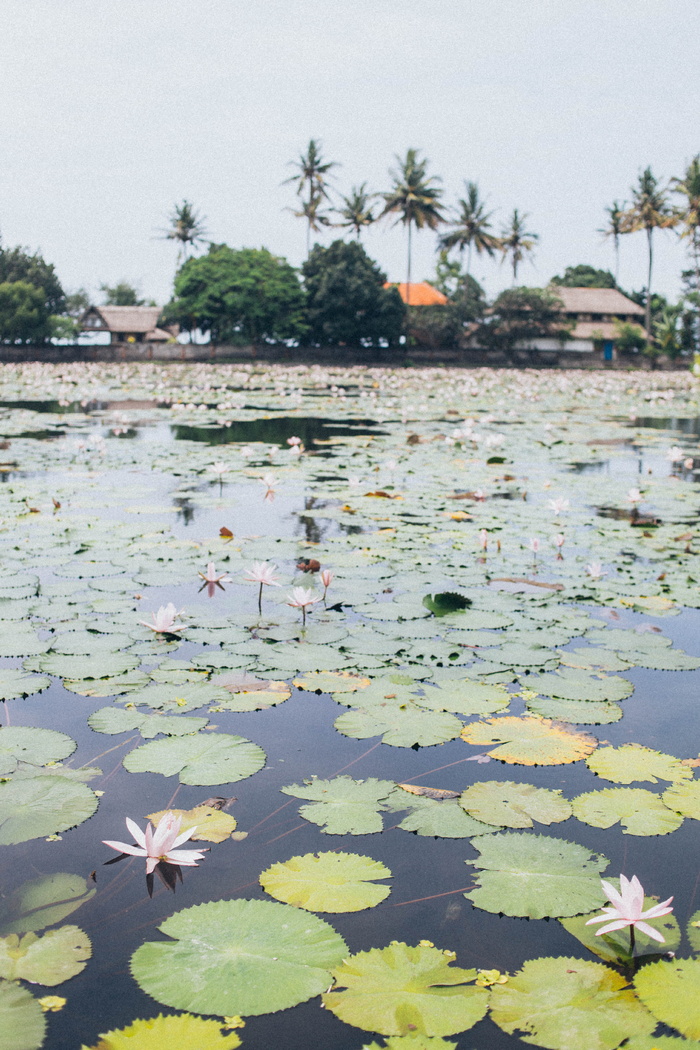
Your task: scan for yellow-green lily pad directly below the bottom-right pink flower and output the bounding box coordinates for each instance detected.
[491,958,655,1050]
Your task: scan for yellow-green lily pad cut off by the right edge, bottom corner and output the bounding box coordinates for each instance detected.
[634,959,700,1040]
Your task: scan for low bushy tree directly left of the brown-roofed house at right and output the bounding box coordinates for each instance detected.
[476,288,569,354]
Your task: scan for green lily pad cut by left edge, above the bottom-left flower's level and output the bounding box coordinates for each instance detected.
[0,776,98,845]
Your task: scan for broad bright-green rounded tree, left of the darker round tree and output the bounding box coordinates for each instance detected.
[164,245,305,343]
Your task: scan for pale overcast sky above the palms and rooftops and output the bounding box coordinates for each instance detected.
[0,0,700,302]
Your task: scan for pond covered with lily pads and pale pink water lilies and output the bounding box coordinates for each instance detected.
[0,363,700,1050]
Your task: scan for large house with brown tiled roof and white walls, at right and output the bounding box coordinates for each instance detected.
[531,285,644,361]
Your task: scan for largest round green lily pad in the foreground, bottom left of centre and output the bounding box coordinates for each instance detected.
[131,900,347,1016]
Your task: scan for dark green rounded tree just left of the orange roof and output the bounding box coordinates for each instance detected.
[301,240,405,347]
